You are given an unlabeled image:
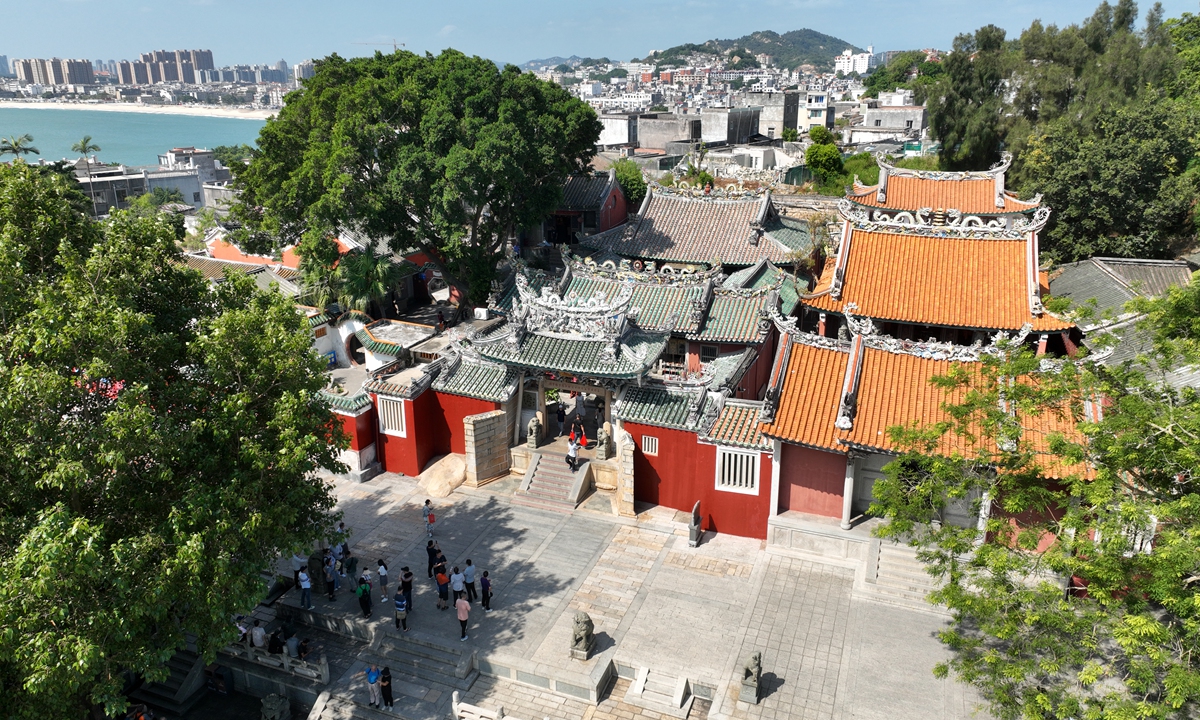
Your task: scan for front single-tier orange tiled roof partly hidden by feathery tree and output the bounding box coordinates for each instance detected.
[761,341,1082,478]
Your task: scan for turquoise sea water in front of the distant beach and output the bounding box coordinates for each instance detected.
[0,107,265,166]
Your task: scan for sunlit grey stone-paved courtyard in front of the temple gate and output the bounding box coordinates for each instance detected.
[223,473,989,720]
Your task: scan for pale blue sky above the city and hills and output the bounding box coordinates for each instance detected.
[9,0,1200,67]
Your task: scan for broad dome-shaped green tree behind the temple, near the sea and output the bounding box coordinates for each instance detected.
[231,50,600,302]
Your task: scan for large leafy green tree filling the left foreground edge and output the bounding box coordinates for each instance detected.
[0,161,342,719]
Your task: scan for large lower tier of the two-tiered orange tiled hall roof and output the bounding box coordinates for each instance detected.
[804,229,1072,331]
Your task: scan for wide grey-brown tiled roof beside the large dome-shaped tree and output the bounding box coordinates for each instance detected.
[581,190,791,268]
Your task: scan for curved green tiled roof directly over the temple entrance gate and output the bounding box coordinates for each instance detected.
[475,325,667,379]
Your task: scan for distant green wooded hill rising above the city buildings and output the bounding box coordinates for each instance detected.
[646,29,863,70]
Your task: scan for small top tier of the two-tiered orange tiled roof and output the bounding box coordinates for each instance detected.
[846,175,1039,215]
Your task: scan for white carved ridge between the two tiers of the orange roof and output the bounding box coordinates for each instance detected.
[838,198,1050,244]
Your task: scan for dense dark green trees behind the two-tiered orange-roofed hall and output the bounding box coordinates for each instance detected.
[916,0,1200,262]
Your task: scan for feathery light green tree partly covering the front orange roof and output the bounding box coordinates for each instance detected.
[872,283,1200,720]
